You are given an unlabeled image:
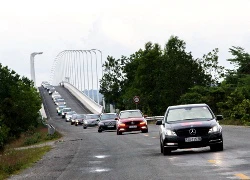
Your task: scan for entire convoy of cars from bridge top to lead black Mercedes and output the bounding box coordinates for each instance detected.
[42,82,223,155]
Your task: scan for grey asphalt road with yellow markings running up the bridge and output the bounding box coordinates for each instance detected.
[10,87,250,180]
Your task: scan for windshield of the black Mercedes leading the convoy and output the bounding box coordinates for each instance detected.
[165,106,213,122]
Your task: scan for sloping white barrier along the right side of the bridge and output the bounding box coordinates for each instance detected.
[63,82,103,114]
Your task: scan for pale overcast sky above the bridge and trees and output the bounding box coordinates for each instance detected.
[0,0,250,86]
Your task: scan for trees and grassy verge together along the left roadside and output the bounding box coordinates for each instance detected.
[0,63,61,180]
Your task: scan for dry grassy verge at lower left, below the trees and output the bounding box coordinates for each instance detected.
[0,125,62,180]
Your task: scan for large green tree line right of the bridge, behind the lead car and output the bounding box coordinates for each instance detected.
[100,36,250,123]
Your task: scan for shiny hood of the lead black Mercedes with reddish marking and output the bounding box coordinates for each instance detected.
[165,120,217,130]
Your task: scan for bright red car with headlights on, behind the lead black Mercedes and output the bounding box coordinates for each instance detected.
[116,110,148,135]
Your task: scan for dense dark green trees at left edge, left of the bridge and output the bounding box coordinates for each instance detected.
[0,63,42,149]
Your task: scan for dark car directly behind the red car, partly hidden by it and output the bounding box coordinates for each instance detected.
[98,113,117,132]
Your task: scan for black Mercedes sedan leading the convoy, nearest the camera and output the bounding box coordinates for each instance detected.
[156,104,223,155]
